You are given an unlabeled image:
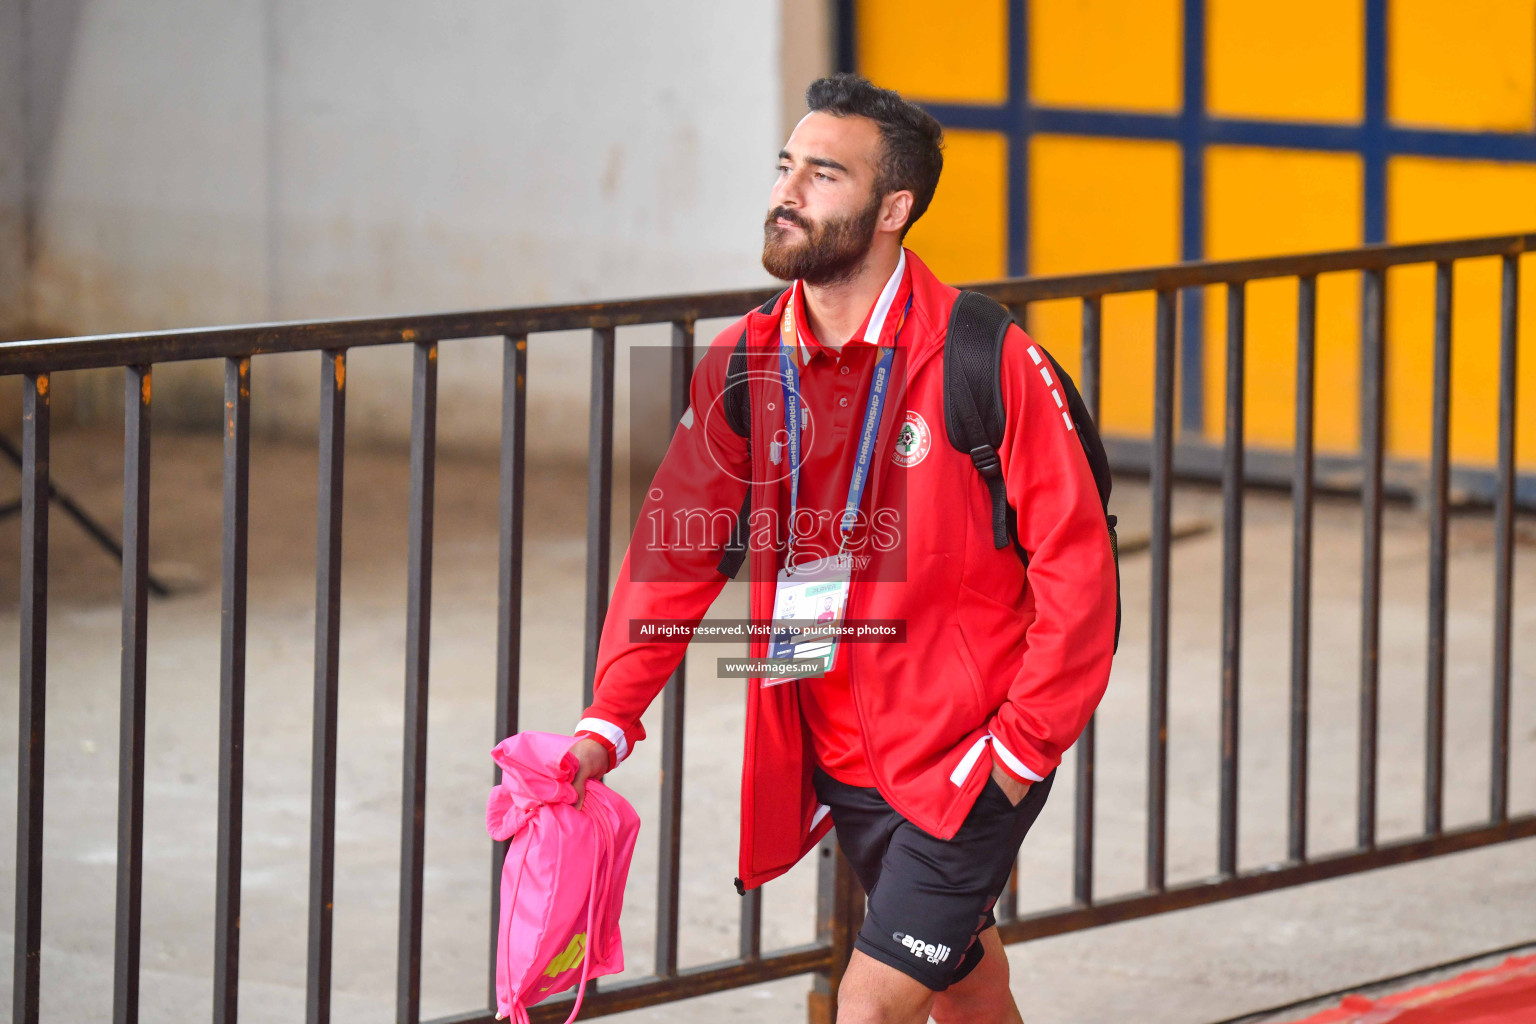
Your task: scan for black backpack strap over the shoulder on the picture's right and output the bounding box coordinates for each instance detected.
[945,292,1014,548]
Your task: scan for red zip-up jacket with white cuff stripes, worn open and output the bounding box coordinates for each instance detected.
[578,250,1117,887]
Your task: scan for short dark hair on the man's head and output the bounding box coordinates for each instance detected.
[805,72,945,238]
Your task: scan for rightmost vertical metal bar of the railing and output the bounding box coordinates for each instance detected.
[1488,256,1521,821]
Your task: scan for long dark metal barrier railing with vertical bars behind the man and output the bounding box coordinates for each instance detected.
[0,235,1536,1024]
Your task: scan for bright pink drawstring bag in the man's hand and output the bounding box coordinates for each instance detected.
[485,732,641,1024]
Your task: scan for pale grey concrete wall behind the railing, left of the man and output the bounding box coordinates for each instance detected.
[0,0,828,454]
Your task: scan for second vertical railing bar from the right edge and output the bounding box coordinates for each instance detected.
[1424,261,1455,835]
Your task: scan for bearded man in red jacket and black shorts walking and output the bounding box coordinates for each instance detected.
[571,75,1115,1024]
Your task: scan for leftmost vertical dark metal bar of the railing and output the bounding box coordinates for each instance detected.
[11,373,51,1024]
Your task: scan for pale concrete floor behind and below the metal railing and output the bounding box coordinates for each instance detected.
[0,433,1536,1024]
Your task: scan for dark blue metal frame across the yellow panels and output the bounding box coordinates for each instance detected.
[834,0,1536,433]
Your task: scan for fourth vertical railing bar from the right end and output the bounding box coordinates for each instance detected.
[1286,276,1318,861]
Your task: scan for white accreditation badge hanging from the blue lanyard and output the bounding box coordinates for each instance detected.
[763,553,852,686]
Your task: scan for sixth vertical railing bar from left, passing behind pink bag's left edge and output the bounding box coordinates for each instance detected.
[485,336,528,1007]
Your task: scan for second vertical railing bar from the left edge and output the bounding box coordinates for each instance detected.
[112,367,151,1024]
